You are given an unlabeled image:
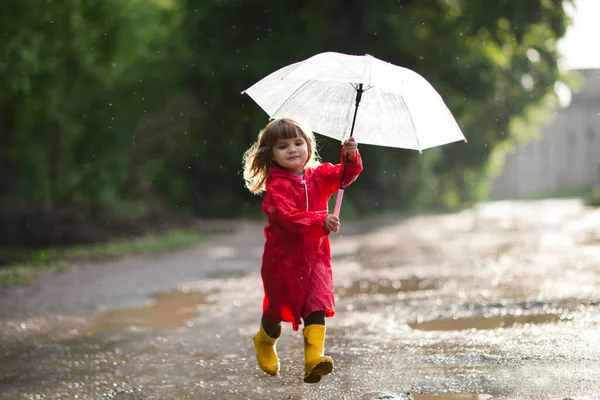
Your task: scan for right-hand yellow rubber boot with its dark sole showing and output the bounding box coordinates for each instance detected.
[302,324,333,383]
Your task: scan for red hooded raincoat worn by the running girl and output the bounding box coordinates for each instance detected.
[261,150,362,331]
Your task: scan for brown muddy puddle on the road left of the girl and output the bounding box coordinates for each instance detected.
[82,291,212,335]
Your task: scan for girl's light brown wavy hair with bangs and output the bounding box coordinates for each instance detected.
[242,118,321,194]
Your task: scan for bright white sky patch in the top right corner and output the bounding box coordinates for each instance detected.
[558,0,600,69]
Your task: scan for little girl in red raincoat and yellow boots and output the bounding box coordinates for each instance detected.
[244,118,362,383]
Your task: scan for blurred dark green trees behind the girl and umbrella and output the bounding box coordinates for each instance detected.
[0,0,568,245]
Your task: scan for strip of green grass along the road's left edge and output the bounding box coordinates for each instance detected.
[0,230,203,287]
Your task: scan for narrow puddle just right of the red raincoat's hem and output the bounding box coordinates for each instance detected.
[336,277,437,298]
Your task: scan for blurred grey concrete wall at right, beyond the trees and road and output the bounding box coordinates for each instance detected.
[491,69,600,198]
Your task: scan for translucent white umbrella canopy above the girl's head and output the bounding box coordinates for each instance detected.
[242,52,466,151]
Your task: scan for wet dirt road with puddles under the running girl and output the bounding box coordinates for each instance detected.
[0,200,600,400]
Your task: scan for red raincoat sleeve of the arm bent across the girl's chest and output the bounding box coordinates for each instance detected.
[263,181,330,237]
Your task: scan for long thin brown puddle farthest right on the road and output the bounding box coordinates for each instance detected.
[409,314,563,331]
